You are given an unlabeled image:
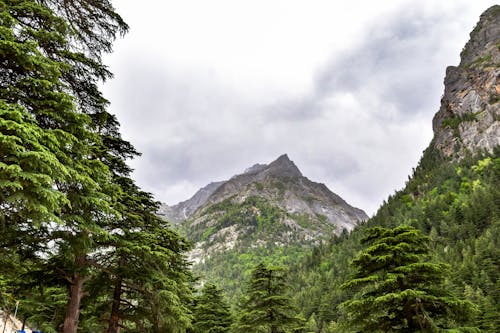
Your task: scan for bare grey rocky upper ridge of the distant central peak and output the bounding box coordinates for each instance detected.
[158,154,368,230]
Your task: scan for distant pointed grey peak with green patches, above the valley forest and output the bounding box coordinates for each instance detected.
[159,155,368,261]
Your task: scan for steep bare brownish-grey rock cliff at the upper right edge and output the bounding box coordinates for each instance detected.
[433,5,500,158]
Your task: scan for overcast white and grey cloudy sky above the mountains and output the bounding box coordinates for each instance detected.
[103,0,494,215]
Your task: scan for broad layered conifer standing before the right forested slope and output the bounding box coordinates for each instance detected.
[340,226,476,332]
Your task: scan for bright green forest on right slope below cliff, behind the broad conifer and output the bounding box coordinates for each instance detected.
[291,148,500,332]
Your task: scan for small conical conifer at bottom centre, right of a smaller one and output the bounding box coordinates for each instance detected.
[235,263,304,333]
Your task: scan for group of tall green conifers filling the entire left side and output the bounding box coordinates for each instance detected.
[0,0,192,333]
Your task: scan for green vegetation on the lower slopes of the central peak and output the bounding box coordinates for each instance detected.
[189,196,334,304]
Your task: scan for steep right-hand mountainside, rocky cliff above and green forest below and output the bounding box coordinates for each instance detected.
[291,6,500,333]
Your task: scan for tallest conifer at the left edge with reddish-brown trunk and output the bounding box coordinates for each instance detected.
[0,0,148,332]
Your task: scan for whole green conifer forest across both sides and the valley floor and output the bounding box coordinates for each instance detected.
[0,0,500,333]
